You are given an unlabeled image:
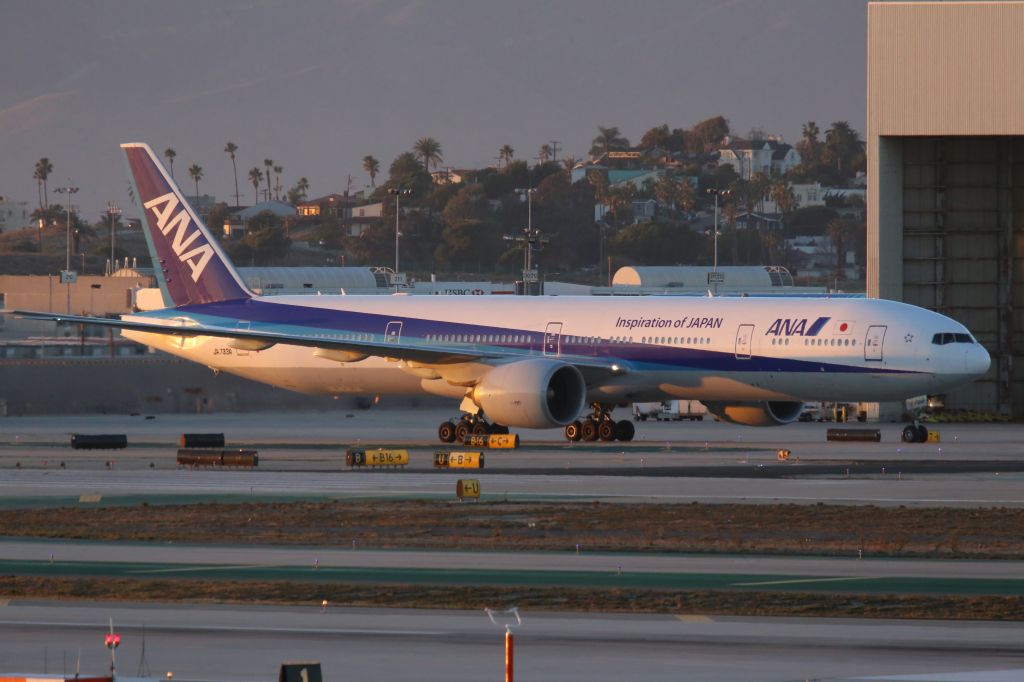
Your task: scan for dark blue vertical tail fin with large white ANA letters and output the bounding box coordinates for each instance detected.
[121,143,252,307]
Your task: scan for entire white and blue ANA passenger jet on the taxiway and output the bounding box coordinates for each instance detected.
[19,143,989,442]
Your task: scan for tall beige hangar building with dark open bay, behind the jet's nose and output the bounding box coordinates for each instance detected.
[866,2,1024,417]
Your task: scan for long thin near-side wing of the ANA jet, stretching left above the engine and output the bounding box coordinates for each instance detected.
[12,310,626,374]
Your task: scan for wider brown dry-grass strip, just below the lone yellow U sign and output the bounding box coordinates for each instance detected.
[0,501,1024,559]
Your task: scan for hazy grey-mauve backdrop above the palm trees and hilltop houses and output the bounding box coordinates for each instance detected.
[0,0,866,219]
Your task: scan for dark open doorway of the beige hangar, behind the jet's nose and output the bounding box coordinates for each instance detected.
[899,136,1024,416]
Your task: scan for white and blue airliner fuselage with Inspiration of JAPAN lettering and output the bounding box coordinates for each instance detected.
[123,296,988,403]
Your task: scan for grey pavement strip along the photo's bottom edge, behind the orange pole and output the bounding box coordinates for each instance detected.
[0,600,1024,682]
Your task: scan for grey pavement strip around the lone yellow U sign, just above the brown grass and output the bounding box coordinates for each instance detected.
[0,467,1024,507]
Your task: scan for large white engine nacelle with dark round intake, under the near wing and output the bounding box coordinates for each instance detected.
[471,358,587,429]
